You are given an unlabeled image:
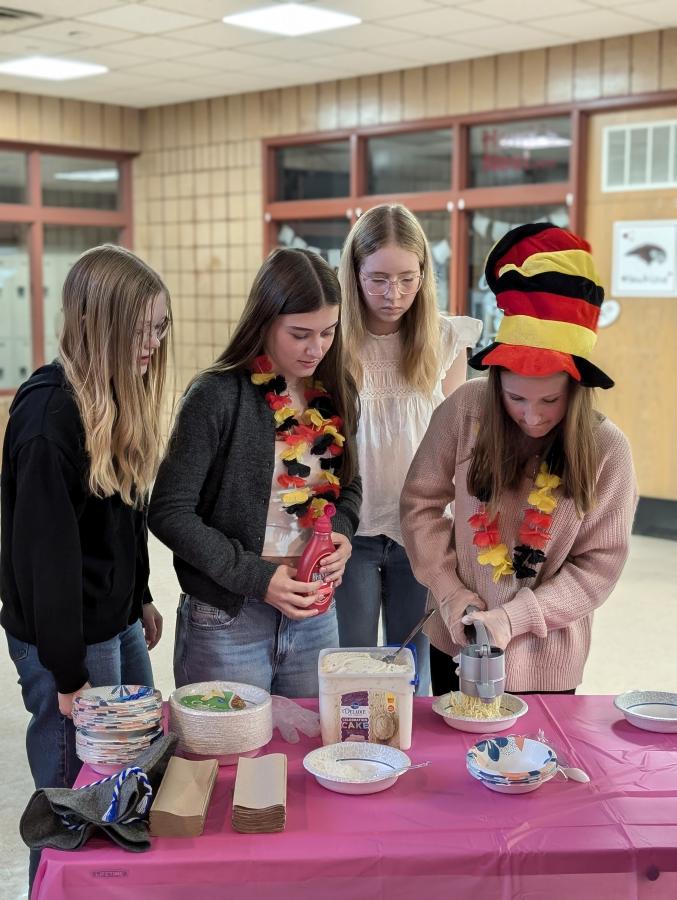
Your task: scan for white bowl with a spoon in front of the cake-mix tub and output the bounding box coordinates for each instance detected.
[303,741,411,794]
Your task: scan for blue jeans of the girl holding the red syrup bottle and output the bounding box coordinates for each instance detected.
[174,594,338,697]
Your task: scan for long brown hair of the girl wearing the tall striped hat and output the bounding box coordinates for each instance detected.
[467,366,601,516]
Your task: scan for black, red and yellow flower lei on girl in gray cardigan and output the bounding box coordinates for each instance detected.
[251,355,345,528]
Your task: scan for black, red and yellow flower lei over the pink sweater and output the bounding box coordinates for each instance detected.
[468,463,562,582]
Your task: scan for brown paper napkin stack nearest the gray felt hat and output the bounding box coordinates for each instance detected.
[150,756,219,837]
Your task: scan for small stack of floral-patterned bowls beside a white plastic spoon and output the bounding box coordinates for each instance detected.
[466,734,557,794]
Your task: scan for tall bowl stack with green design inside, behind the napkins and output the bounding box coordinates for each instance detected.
[169,681,273,766]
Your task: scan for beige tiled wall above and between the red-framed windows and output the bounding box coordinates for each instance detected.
[0,29,677,478]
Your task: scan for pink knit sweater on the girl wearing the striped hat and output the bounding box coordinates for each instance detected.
[400,378,637,692]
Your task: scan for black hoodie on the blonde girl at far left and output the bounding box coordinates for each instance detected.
[0,364,152,693]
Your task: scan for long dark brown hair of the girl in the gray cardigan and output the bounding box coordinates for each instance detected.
[206,247,358,484]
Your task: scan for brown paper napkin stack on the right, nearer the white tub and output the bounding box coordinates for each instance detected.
[233,753,287,834]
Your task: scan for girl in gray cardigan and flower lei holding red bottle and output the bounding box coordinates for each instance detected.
[149,249,361,697]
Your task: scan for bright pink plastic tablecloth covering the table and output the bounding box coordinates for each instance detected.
[33,696,677,900]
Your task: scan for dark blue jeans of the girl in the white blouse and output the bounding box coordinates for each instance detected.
[336,534,430,696]
